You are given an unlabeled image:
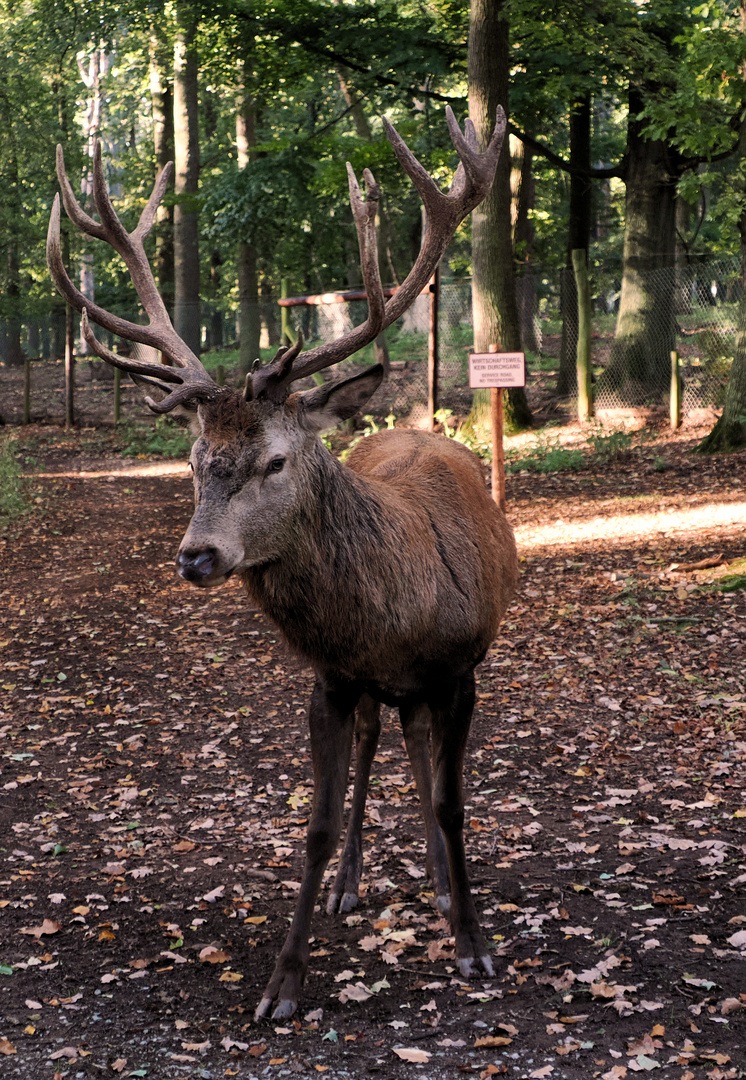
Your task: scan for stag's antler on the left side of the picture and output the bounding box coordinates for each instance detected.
[46,141,219,413]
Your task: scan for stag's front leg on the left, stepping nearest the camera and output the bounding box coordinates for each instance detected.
[255,678,360,1020]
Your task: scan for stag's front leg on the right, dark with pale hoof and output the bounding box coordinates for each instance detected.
[432,672,494,977]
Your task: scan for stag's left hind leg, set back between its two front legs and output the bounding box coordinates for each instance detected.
[326,693,381,915]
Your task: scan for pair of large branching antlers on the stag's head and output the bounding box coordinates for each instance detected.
[46,107,506,413]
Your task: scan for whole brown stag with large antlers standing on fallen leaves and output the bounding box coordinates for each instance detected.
[48,108,518,1021]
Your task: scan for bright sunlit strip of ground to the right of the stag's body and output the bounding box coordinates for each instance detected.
[516,502,746,551]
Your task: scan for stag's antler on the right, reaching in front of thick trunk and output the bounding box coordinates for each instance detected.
[254,106,506,400]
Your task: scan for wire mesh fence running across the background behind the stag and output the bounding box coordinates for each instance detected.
[0,258,742,422]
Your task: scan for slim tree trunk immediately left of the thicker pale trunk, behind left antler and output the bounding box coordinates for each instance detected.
[149,24,174,314]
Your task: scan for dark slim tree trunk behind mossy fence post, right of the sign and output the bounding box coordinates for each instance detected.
[557,94,592,397]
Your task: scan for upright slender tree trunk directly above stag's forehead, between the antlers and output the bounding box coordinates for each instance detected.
[235,52,261,375]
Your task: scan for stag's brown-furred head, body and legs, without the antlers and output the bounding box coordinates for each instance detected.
[177,368,517,1018]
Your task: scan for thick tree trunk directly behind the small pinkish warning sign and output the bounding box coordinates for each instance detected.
[469,0,531,429]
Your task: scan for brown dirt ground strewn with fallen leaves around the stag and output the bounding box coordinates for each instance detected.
[0,403,746,1080]
